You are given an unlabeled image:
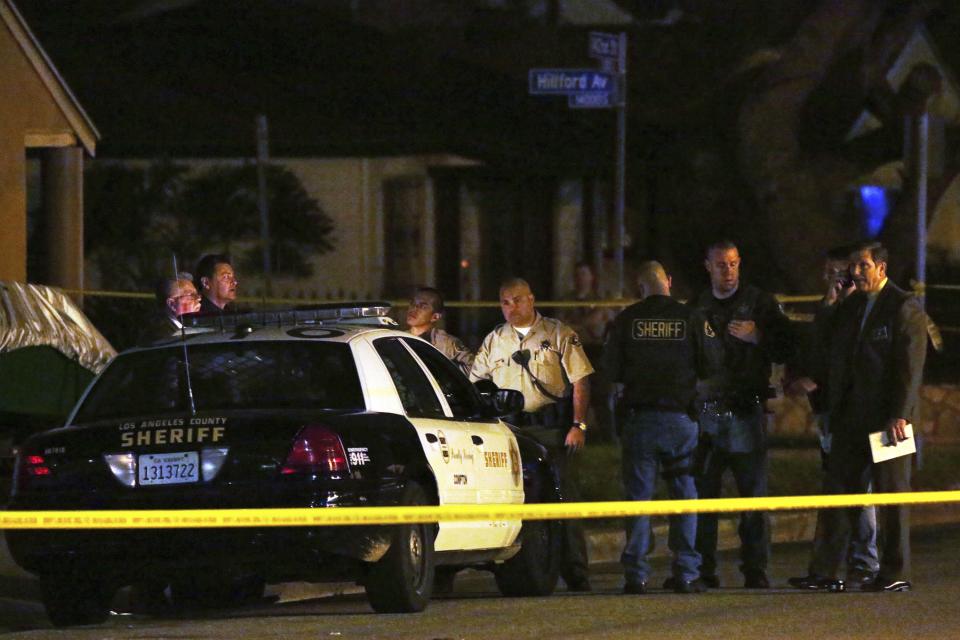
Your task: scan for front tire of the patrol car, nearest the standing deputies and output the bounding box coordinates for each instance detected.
[493,520,561,597]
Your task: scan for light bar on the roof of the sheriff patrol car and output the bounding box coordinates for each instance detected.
[184,301,395,330]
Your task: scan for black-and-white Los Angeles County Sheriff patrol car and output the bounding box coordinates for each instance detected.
[7,303,560,625]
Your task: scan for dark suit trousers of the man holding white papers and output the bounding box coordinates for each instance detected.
[810,434,913,581]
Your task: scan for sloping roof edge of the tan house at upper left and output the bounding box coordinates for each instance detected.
[0,0,100,156]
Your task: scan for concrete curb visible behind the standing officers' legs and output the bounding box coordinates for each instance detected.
[587,504,960,564]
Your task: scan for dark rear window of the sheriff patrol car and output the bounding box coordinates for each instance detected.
[74,342,364,423]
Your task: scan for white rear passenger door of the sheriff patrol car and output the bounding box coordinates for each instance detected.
[373,337,485,551]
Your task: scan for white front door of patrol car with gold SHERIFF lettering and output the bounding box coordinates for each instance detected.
[404,338,524,548]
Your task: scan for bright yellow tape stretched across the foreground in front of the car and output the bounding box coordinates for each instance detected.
[0,491,960,529]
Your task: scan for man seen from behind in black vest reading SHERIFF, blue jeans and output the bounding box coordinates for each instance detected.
[603,261,706,595]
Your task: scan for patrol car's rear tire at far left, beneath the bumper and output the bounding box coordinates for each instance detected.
[40,573,113,627]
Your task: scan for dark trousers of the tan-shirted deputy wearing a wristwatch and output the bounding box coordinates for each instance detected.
[512,399,589,585]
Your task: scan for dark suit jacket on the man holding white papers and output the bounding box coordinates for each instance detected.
[824,280,927,444]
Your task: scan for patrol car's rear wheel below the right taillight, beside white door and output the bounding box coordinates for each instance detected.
[364,482,436,613]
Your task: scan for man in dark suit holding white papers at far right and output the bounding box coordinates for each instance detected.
[811,243,927,591]
